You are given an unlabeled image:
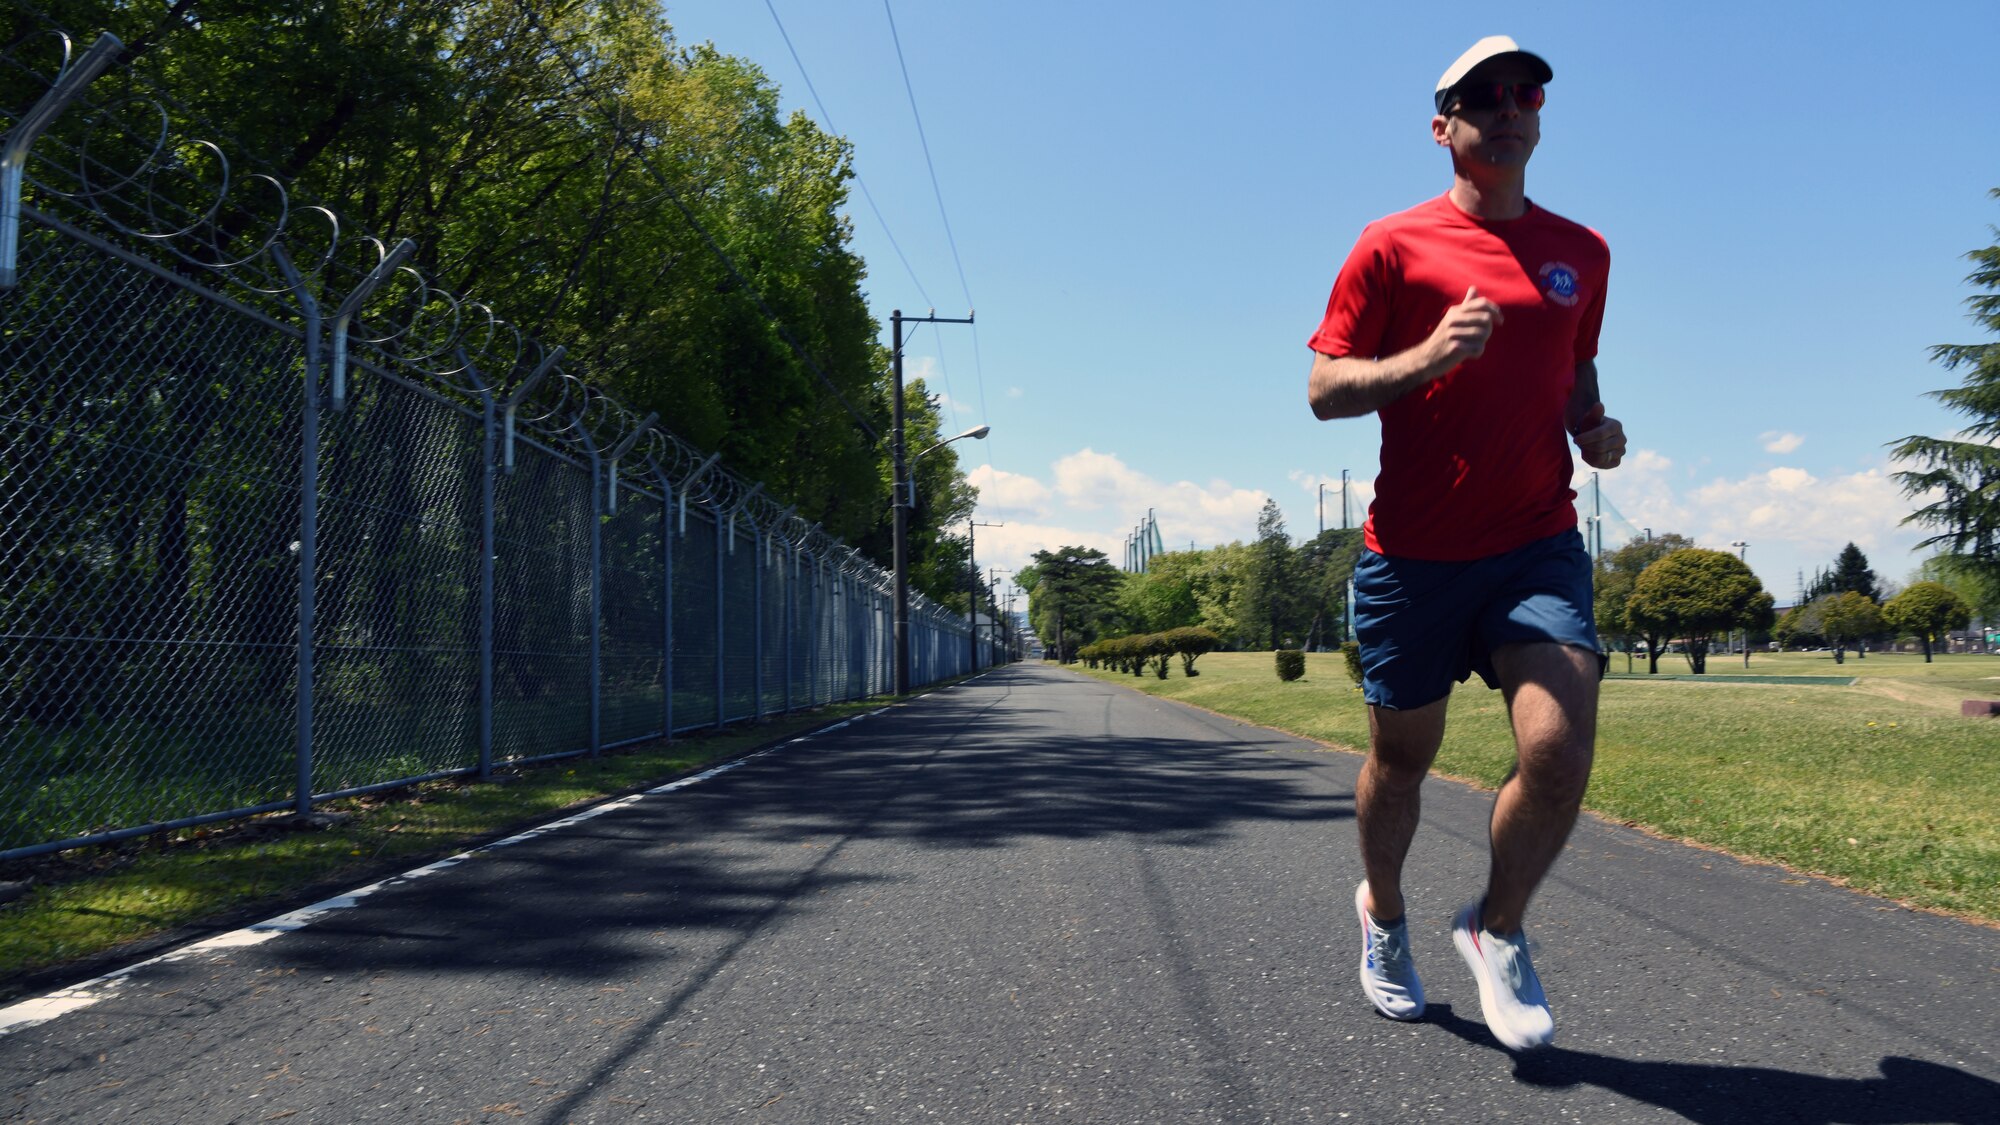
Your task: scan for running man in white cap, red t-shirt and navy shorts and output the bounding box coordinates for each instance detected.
[1308,36,1626,1051]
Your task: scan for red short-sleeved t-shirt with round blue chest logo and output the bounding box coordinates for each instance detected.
[1308,196,1610,560]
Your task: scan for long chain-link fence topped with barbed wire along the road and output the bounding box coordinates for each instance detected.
[0,34,996,859]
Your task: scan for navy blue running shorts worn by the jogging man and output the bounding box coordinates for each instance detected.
[1354,528,1598,711]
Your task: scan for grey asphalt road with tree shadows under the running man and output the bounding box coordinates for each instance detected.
[0,667,2000,1123]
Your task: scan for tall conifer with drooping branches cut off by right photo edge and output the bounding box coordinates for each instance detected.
[1894,188,2000,577]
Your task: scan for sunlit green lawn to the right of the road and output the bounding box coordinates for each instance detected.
[1078,653,2000,921]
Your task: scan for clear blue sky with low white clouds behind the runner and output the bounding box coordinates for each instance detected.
[666,0,2000,605]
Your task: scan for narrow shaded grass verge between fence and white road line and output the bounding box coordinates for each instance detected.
[0,699,884,1001]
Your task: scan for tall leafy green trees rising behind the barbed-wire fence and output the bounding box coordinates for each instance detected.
[0,0,972,605]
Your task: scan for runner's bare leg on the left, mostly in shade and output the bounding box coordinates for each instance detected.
[1354,697,1450,921]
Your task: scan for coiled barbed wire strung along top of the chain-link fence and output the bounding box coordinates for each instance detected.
[0,14,968,613]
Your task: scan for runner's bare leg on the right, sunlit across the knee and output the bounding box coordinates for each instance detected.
[1480,643,1598,933]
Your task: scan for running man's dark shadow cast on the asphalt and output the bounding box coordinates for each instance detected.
[1424,1003,2000,1125]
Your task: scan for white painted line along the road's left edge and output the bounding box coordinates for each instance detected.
[0,707,872,1037]
